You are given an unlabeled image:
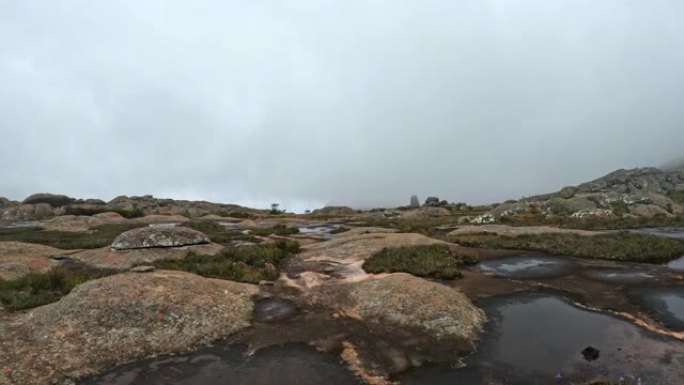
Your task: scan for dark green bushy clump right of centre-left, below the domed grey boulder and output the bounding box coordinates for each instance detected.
[154,240,299,283]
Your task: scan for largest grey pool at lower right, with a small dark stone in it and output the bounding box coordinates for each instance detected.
[399,294,684,385]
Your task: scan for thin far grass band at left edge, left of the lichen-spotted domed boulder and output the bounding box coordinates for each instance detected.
[0,223,145,250]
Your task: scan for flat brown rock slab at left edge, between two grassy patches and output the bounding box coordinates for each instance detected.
[0,242,64,280]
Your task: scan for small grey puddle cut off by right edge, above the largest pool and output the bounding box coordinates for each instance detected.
[636,286,684,331]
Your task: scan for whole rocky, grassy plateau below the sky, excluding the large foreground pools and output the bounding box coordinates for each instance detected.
[0,169,684,385]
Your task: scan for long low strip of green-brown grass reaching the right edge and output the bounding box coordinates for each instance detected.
[449,232,684,263]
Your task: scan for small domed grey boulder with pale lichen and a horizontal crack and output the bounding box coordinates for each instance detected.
[111,226,209,250]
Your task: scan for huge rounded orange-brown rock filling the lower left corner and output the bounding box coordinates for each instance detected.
[0,271,257,385]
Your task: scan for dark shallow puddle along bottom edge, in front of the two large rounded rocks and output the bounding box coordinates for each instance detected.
[82,345,361,385]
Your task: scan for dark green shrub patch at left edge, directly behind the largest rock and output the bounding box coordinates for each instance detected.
[0,264,115,310]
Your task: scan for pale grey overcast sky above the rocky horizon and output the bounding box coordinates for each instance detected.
[0,0,684,211]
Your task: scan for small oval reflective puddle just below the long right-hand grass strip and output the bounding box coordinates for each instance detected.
[478,255,577,278]
